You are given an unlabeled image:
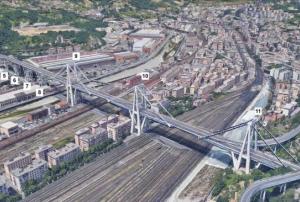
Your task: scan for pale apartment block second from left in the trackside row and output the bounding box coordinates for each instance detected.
[48,143,80,168]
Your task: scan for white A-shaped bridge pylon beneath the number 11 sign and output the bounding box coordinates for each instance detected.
[231,120,257,174]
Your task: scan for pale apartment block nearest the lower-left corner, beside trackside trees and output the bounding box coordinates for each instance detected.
[11,160,48,192]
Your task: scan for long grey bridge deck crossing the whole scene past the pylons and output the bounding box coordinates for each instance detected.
[0,55,300,170]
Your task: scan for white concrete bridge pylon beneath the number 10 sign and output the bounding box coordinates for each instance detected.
[130,86,148,136]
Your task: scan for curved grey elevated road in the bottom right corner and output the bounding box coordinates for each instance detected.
[240,171,300,202]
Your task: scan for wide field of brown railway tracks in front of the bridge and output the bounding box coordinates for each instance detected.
[24,135,202,202]
